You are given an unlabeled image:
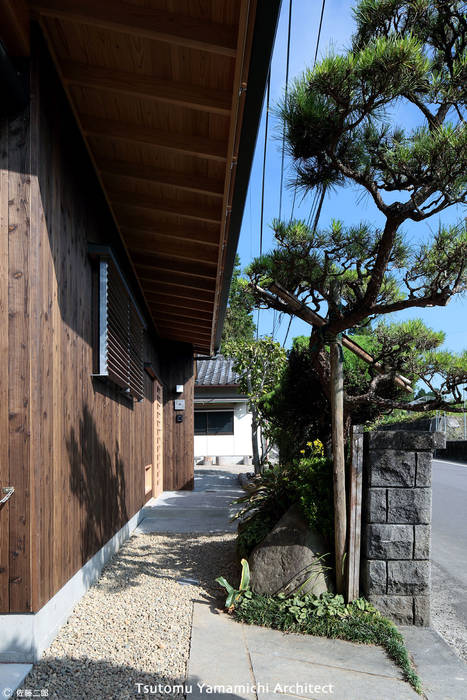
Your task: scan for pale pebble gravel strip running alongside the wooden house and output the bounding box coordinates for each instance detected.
[22,534,238,700]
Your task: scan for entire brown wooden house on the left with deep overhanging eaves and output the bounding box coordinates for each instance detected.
[0,0,280,661]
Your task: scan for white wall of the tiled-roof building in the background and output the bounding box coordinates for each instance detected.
[195,401,252,458]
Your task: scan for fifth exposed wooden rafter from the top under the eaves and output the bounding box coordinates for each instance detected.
[106,187,222,224]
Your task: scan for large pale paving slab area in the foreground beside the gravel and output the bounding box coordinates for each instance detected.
[187,603,419,700]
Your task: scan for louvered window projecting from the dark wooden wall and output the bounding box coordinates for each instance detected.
[90,246,145,400]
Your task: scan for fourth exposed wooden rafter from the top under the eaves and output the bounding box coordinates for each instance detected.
[97,158,224,199]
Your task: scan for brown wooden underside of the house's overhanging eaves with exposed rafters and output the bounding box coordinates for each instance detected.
[6,0,280,353]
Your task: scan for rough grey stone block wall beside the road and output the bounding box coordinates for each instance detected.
[361,430,445,626]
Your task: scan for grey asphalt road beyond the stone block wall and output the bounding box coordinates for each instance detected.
[432,460,467,625]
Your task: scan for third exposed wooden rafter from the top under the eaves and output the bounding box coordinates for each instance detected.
[84,114,227,163]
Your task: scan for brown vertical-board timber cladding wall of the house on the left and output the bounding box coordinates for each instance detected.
[0,41,193,613]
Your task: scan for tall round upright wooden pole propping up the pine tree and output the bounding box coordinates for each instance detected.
[330,336,347,593]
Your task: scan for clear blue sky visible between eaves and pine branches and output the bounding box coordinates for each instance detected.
[238,0,467,352]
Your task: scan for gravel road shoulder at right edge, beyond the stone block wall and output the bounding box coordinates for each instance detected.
[431,562,467,661]
